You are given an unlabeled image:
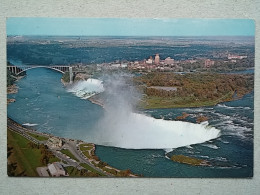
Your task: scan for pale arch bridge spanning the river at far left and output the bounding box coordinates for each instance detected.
[7,65,73,83]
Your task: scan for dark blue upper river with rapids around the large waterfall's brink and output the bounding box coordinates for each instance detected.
[96,93,254,177]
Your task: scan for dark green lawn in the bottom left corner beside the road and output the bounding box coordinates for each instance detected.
[7,130,59,176]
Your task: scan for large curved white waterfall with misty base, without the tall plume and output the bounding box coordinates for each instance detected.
[94,113,220,149]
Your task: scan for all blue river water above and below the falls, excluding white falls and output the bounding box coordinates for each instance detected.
[8,68,254,177]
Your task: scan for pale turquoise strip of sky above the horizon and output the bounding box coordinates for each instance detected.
[6,17,255,36]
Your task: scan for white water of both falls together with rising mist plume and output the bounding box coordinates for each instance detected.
[69,74,220,149]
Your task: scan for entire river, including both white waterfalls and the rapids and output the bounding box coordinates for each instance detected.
[8,68,254,177]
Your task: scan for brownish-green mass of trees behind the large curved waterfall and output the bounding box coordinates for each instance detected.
[137,73,254,101]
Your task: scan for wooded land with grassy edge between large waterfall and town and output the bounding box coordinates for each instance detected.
[137,73,254,109]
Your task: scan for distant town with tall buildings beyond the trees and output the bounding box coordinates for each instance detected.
[73,53,251,72]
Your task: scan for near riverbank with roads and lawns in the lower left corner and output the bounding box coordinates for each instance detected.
[7,118,137,177]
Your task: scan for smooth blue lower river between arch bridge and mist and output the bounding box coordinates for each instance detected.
[7,68,103,141]
